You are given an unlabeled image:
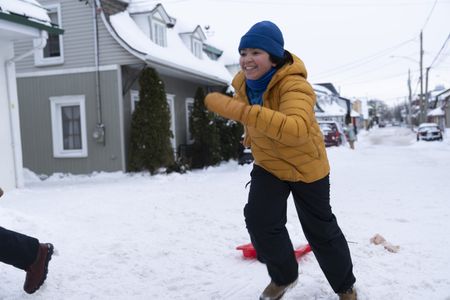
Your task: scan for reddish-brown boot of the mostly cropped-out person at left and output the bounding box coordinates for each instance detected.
[23,243,53,294]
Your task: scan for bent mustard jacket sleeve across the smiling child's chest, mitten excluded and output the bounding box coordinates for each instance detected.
[241,81,315,146]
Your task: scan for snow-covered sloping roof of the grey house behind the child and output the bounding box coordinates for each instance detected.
[106,1,232,84]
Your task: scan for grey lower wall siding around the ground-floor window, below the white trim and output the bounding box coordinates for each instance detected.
[18,70,125,175]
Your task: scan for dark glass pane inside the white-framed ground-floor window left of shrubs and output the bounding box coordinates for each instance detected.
[61,105,82,150]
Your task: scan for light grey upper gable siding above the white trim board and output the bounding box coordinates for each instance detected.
[14,0,141,75]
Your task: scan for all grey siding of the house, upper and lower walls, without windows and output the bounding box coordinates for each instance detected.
[15,0,230,175]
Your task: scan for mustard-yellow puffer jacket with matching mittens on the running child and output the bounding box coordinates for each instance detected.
[205,55,330,183]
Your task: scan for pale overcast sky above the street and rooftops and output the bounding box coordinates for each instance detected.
[140,0,450,104]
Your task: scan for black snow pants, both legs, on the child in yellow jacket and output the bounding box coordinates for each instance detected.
[244,165,356,293]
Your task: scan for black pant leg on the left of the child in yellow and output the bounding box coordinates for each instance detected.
[244,165,298,285]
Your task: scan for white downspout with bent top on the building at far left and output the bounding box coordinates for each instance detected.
[5,30,48,188]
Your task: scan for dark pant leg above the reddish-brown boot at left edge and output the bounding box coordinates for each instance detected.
[0,227,39,270]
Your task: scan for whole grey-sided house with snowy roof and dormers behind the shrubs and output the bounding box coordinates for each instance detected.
[14,0,231,175]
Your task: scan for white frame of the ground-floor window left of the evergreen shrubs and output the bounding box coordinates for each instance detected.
[50,95,88,158]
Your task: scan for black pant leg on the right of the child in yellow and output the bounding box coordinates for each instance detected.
[291,176,356,293]
